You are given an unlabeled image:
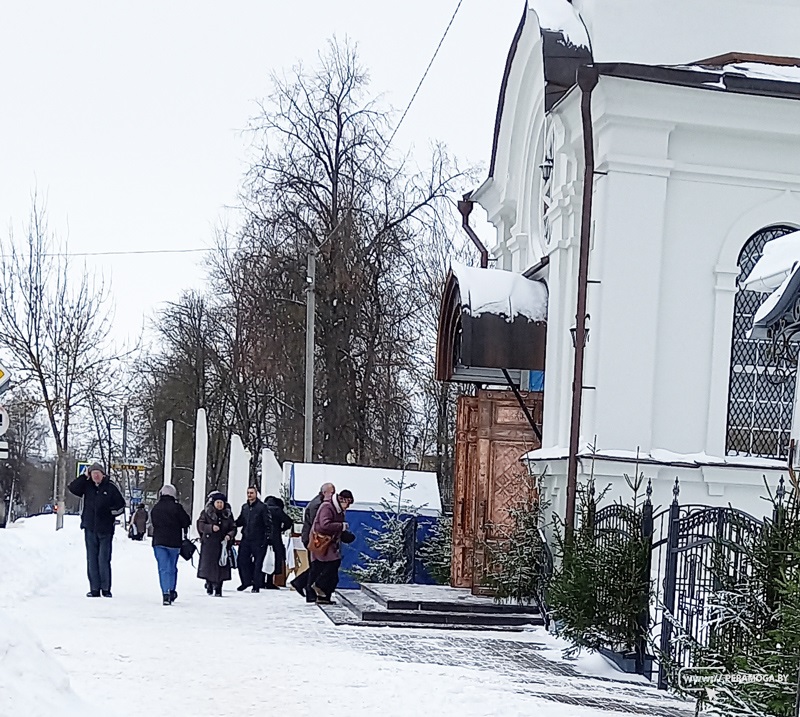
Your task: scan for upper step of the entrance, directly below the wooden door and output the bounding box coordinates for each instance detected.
[361,583,540,616]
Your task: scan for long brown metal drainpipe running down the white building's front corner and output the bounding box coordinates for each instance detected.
[564,65,599,538]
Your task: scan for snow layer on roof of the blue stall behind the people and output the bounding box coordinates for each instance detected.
[283,463,442,515]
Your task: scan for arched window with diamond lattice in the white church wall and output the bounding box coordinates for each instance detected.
[725,225,797,458]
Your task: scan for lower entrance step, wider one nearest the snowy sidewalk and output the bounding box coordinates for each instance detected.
[336,590,544,629]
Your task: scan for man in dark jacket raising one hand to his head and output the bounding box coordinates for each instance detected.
[68,463,125,597]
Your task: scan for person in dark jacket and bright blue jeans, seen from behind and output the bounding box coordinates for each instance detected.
[150,485,192,605]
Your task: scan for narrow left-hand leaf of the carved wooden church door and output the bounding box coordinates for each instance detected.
[450,396,478,588]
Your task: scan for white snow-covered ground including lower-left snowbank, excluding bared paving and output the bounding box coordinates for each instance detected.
[0,516,688,717]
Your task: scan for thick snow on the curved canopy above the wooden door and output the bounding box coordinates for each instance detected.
[452,263,547,321]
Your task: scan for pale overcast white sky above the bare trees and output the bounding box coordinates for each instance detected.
[0,0,524,346]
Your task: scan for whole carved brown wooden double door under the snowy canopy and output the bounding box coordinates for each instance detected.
[450,391,542,594]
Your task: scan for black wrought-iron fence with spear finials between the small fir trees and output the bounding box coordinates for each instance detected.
[548,479,772,689]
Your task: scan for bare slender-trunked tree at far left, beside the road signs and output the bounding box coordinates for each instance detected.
[0,195,117,529]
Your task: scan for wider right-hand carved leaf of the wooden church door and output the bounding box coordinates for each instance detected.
[472,391,542,595]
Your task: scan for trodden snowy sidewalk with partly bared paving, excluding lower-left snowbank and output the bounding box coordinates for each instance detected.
[0,518,693,717]
